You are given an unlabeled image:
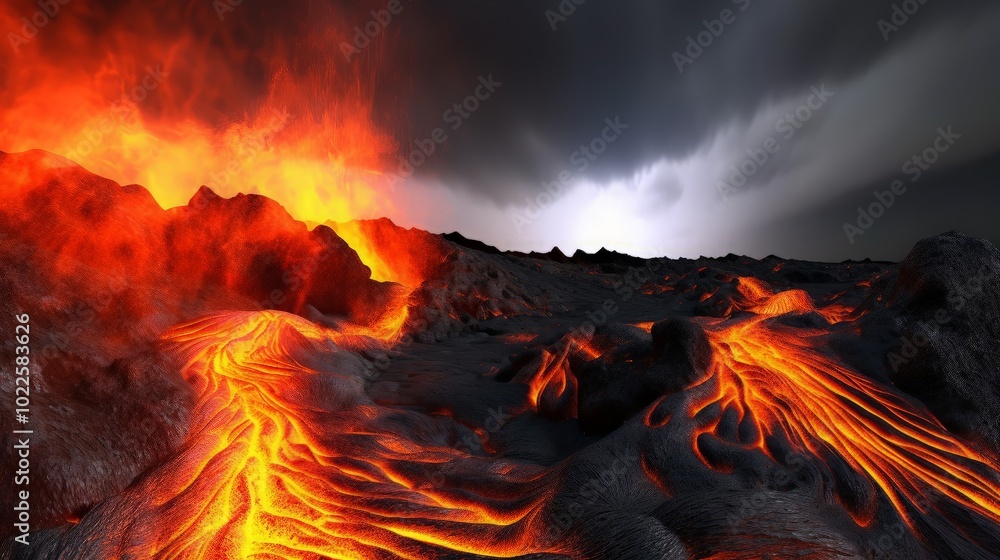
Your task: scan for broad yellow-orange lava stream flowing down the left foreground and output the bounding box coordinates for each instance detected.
[138,312,548,559]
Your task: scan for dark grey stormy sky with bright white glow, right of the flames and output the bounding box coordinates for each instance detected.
[390,0,1000,260]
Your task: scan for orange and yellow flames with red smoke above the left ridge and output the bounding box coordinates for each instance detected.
[0,0,405,230]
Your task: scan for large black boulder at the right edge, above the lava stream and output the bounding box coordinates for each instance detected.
[860,232,1000,453]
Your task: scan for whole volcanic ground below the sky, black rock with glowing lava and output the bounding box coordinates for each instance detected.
[0,152,1000,560]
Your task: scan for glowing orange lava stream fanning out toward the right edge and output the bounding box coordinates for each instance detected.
[689,280,1000,527]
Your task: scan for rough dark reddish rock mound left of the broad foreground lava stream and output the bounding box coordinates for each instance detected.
[0,348,194,527]
